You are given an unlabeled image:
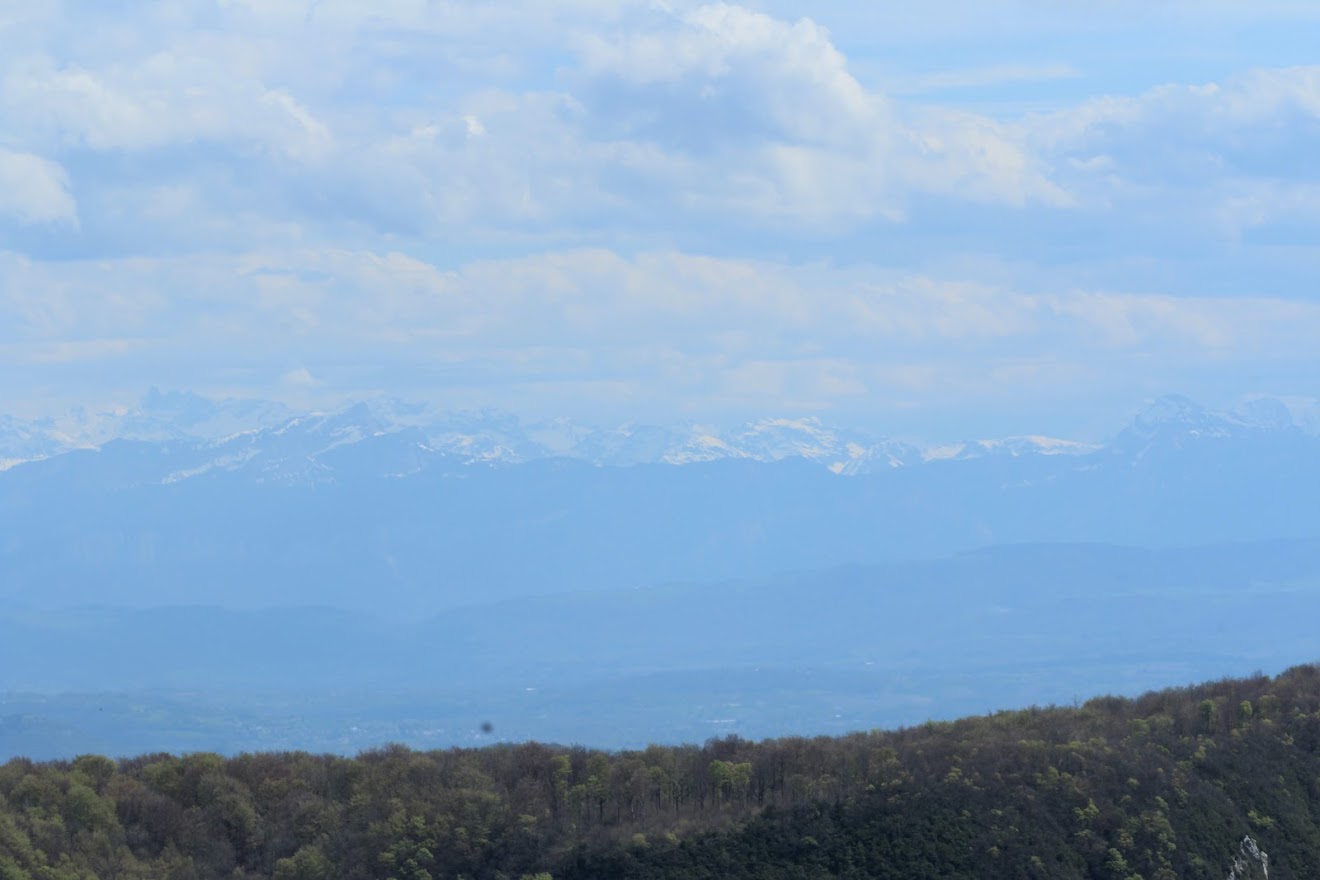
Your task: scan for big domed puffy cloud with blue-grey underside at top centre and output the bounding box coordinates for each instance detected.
[570,4,1067,223]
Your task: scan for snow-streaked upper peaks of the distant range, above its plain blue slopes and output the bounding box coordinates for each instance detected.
[0,389,1313,486]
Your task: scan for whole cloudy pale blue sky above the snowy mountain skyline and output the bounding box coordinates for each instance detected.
[0,0,1320,438]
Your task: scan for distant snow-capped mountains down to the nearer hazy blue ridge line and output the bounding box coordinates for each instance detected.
[0,387,1320,612]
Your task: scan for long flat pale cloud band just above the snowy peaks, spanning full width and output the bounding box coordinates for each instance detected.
[0,249,1320,427]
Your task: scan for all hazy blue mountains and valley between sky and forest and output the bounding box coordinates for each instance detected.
[0,392,1320,755]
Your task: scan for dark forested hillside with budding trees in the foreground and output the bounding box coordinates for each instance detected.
[0,666,1320,880]
